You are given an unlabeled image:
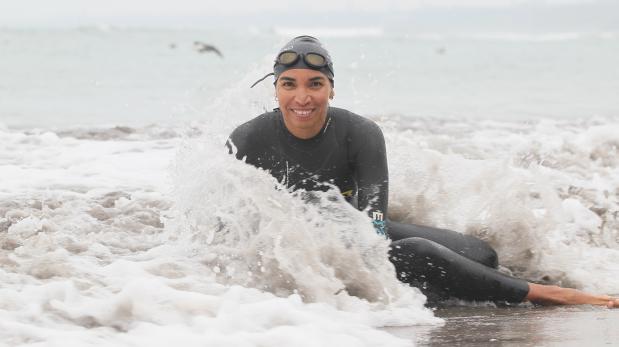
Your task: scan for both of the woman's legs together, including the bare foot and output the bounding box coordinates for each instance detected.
[387,221,619,308]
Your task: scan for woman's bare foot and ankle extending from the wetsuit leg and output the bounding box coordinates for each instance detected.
[525,283,619,308]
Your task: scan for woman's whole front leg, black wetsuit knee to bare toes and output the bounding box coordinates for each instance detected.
[389,237,619,308]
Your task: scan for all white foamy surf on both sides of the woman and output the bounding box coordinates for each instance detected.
[0,114,619,345]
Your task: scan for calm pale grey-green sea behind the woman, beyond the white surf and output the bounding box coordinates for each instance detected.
[0,27,619,127]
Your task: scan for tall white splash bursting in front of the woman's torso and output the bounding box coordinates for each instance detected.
[168,132,432,303]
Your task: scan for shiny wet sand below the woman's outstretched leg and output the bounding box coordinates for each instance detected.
[385,306,619,347]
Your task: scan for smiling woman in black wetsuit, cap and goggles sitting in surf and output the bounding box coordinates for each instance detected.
[227,36,619,307]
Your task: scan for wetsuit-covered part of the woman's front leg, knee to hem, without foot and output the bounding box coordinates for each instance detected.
[389,237,529,303]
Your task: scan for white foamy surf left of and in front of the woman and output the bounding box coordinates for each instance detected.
[0,125,440,346]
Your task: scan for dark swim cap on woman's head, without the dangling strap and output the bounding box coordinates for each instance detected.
[273,35,335,82]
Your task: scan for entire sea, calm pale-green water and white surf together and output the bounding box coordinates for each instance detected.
[0,28,619,346]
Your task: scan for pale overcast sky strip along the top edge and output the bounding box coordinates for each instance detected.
[0,0,615,27]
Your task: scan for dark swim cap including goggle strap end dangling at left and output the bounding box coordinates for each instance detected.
[250,35,335,88]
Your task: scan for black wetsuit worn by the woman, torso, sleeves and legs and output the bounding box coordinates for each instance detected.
[227,107,528,302]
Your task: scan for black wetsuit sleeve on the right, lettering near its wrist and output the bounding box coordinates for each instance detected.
[353,122,389,235]
